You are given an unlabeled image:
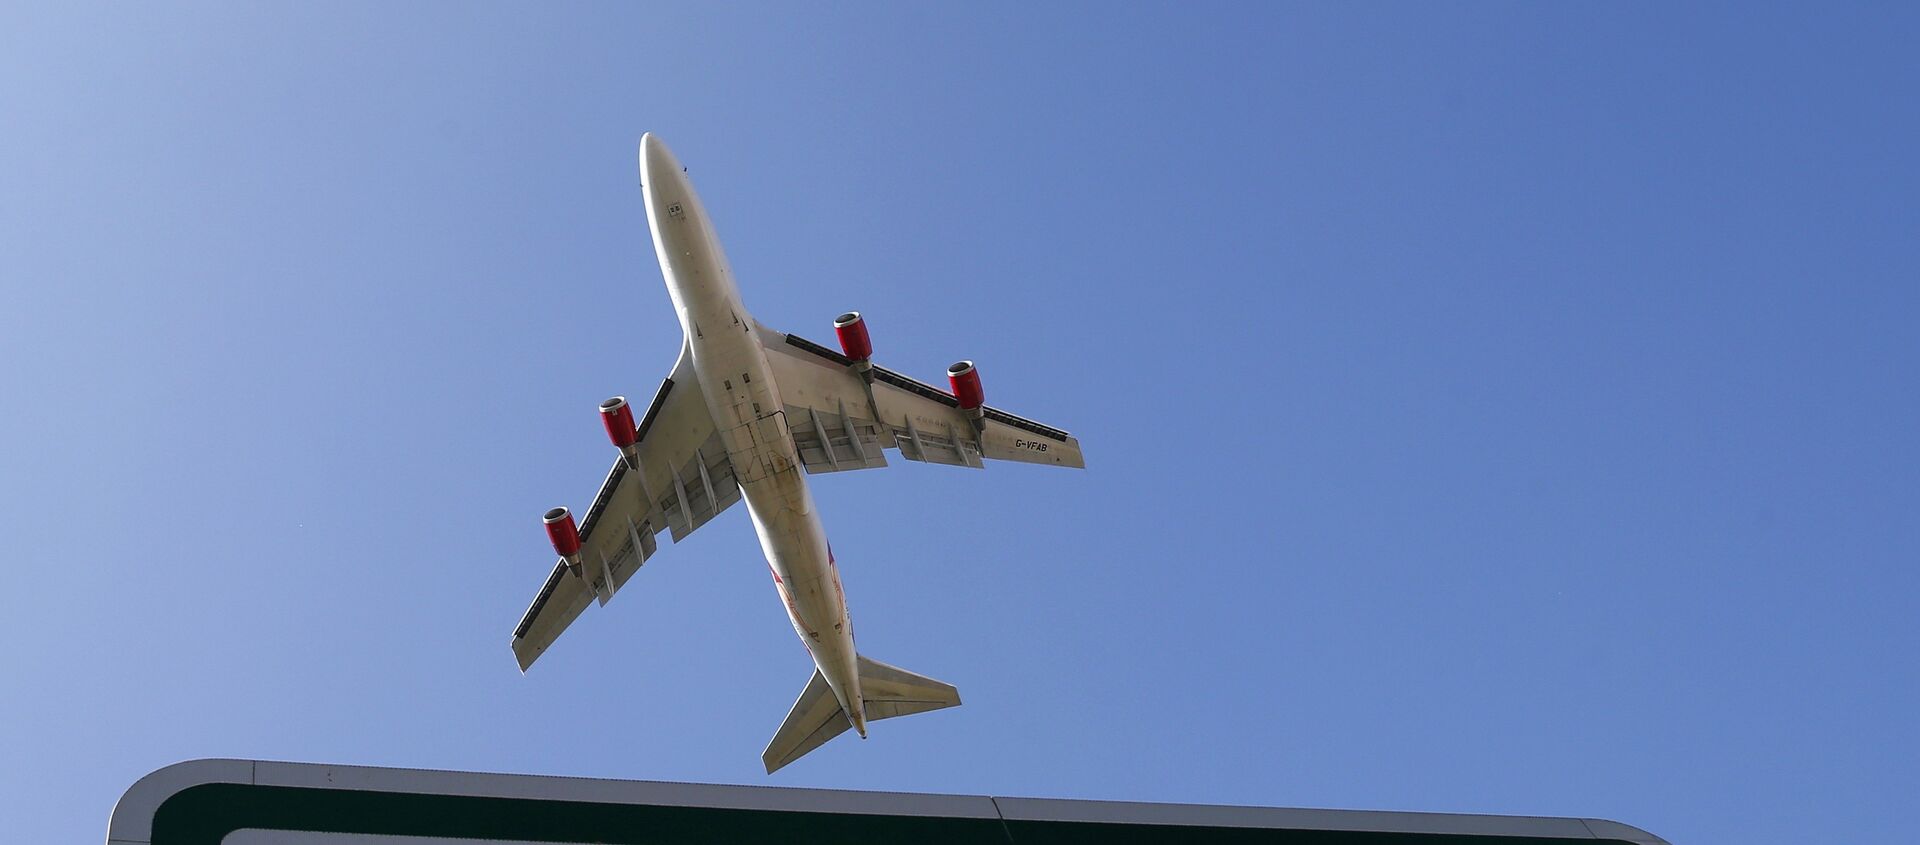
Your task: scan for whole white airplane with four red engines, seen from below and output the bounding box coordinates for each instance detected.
[513,133,1087,774]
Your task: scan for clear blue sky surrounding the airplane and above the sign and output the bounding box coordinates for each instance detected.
[0,4,1920,843]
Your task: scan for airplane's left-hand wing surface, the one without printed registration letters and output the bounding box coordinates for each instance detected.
[513,346,739,672]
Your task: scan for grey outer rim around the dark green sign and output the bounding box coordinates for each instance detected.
[108,759,1668,845]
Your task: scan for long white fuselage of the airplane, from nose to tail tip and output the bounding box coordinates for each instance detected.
[639,134,866,736]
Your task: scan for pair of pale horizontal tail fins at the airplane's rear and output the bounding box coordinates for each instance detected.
[760,655,960,774]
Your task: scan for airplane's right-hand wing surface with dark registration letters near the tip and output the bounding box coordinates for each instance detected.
[758,326,1087,472]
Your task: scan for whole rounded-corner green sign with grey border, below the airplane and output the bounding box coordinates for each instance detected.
[108,761,1667,845]
